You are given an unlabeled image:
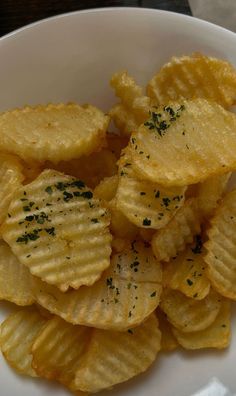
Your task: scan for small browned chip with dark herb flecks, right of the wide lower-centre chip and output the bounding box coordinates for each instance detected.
[163,235,210,300]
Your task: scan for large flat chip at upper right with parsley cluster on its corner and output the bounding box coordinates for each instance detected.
[130,99,236,186]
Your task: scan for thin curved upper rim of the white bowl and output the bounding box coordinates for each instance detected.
[0,6,236,44]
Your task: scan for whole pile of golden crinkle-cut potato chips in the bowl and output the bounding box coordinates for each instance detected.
[0,54,236,395]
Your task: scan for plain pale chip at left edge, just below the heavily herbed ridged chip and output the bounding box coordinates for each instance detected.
[0,240,34,305]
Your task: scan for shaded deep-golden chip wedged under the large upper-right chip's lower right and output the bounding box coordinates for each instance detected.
[197,172,231,216]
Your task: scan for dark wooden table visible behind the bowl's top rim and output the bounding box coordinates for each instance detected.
[0,0,191,36]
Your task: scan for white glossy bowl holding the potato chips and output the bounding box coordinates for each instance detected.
[0,8,236,396]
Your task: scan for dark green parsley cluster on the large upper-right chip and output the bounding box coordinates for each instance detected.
[144,105,185,137]
